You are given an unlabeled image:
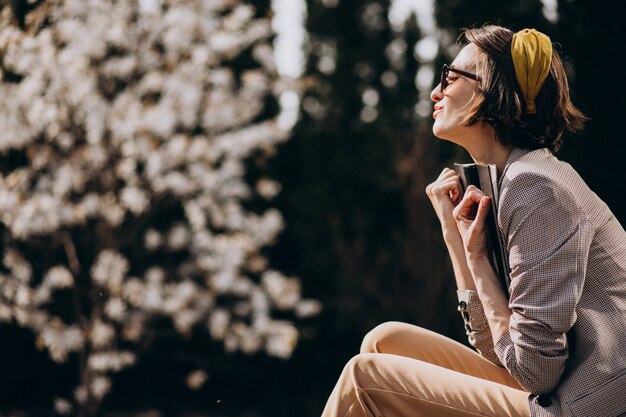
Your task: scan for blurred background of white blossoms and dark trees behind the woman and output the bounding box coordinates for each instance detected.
[0,0,626,417]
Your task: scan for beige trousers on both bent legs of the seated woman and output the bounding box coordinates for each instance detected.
[322,322,529,417]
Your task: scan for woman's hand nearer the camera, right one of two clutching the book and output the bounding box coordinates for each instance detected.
[453,185,490,258]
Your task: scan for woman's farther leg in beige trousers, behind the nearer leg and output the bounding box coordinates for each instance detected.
[361,322,522,390]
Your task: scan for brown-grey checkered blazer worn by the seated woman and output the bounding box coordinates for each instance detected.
[458,148,626,417]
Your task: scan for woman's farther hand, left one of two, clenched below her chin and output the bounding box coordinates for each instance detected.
[426,168,461,234]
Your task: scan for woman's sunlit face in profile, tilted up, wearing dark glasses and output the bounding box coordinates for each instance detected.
[430,43,480,145]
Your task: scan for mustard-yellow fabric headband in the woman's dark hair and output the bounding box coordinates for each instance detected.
[511,29,552,114]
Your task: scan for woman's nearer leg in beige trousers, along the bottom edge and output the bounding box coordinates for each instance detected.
[323,353,529,417]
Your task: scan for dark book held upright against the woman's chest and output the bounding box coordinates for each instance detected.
[454,163,511,295]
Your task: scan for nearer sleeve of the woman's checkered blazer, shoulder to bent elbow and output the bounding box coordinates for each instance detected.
[495,173,594,395]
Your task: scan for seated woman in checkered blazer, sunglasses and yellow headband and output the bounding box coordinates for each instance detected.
[323,26,626,417]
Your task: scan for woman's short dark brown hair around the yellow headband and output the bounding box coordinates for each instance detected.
[463,25,587,153]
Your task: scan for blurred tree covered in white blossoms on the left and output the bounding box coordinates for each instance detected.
[0,0,319,414]
